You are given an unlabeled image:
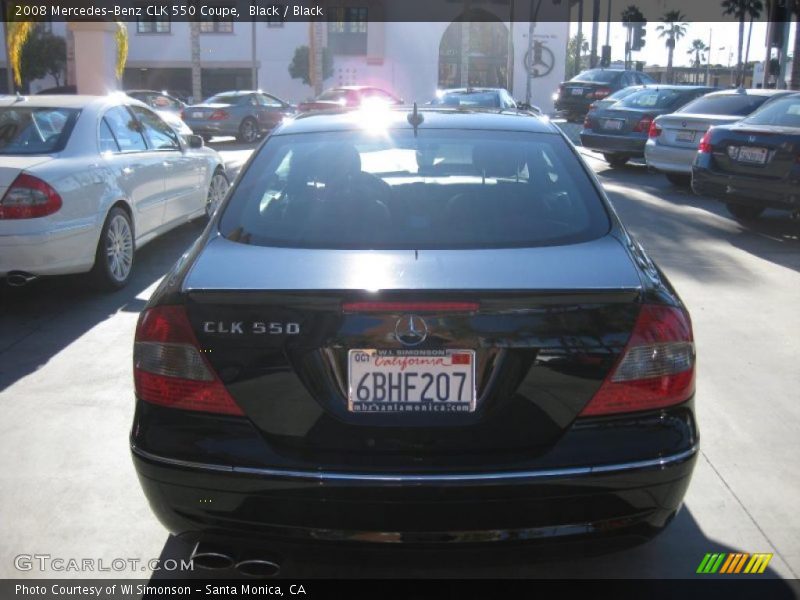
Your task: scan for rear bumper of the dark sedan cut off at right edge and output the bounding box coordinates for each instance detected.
[692,166,800,210]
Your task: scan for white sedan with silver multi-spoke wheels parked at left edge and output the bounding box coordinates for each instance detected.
[0,94,229,289]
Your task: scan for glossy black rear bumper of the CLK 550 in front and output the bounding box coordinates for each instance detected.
[132,406,698,544]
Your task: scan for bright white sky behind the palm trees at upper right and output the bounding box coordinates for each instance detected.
[570,21,795,66]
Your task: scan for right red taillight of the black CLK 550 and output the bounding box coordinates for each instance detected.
[581,304,695,417]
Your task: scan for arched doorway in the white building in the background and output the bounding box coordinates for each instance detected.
[439,10,509,89]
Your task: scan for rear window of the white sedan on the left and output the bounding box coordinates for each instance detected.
[0,106,80,154]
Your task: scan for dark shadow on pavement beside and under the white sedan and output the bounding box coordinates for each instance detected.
[0,219,205,391]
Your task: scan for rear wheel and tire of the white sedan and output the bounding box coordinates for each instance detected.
[91,207,136,291]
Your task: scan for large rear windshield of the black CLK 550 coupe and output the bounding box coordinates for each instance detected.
[220,129,610,249]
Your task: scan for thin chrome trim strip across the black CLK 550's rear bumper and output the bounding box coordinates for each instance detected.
[131,444,699,483]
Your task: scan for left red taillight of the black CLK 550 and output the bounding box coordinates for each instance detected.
[133,306,244,415]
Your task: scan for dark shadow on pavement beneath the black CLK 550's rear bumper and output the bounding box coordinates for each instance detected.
[151,507,789,590]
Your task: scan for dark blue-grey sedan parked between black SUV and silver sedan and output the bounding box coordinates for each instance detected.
[580,85,713,167]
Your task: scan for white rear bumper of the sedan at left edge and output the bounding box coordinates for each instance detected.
[0,223,100,277]
